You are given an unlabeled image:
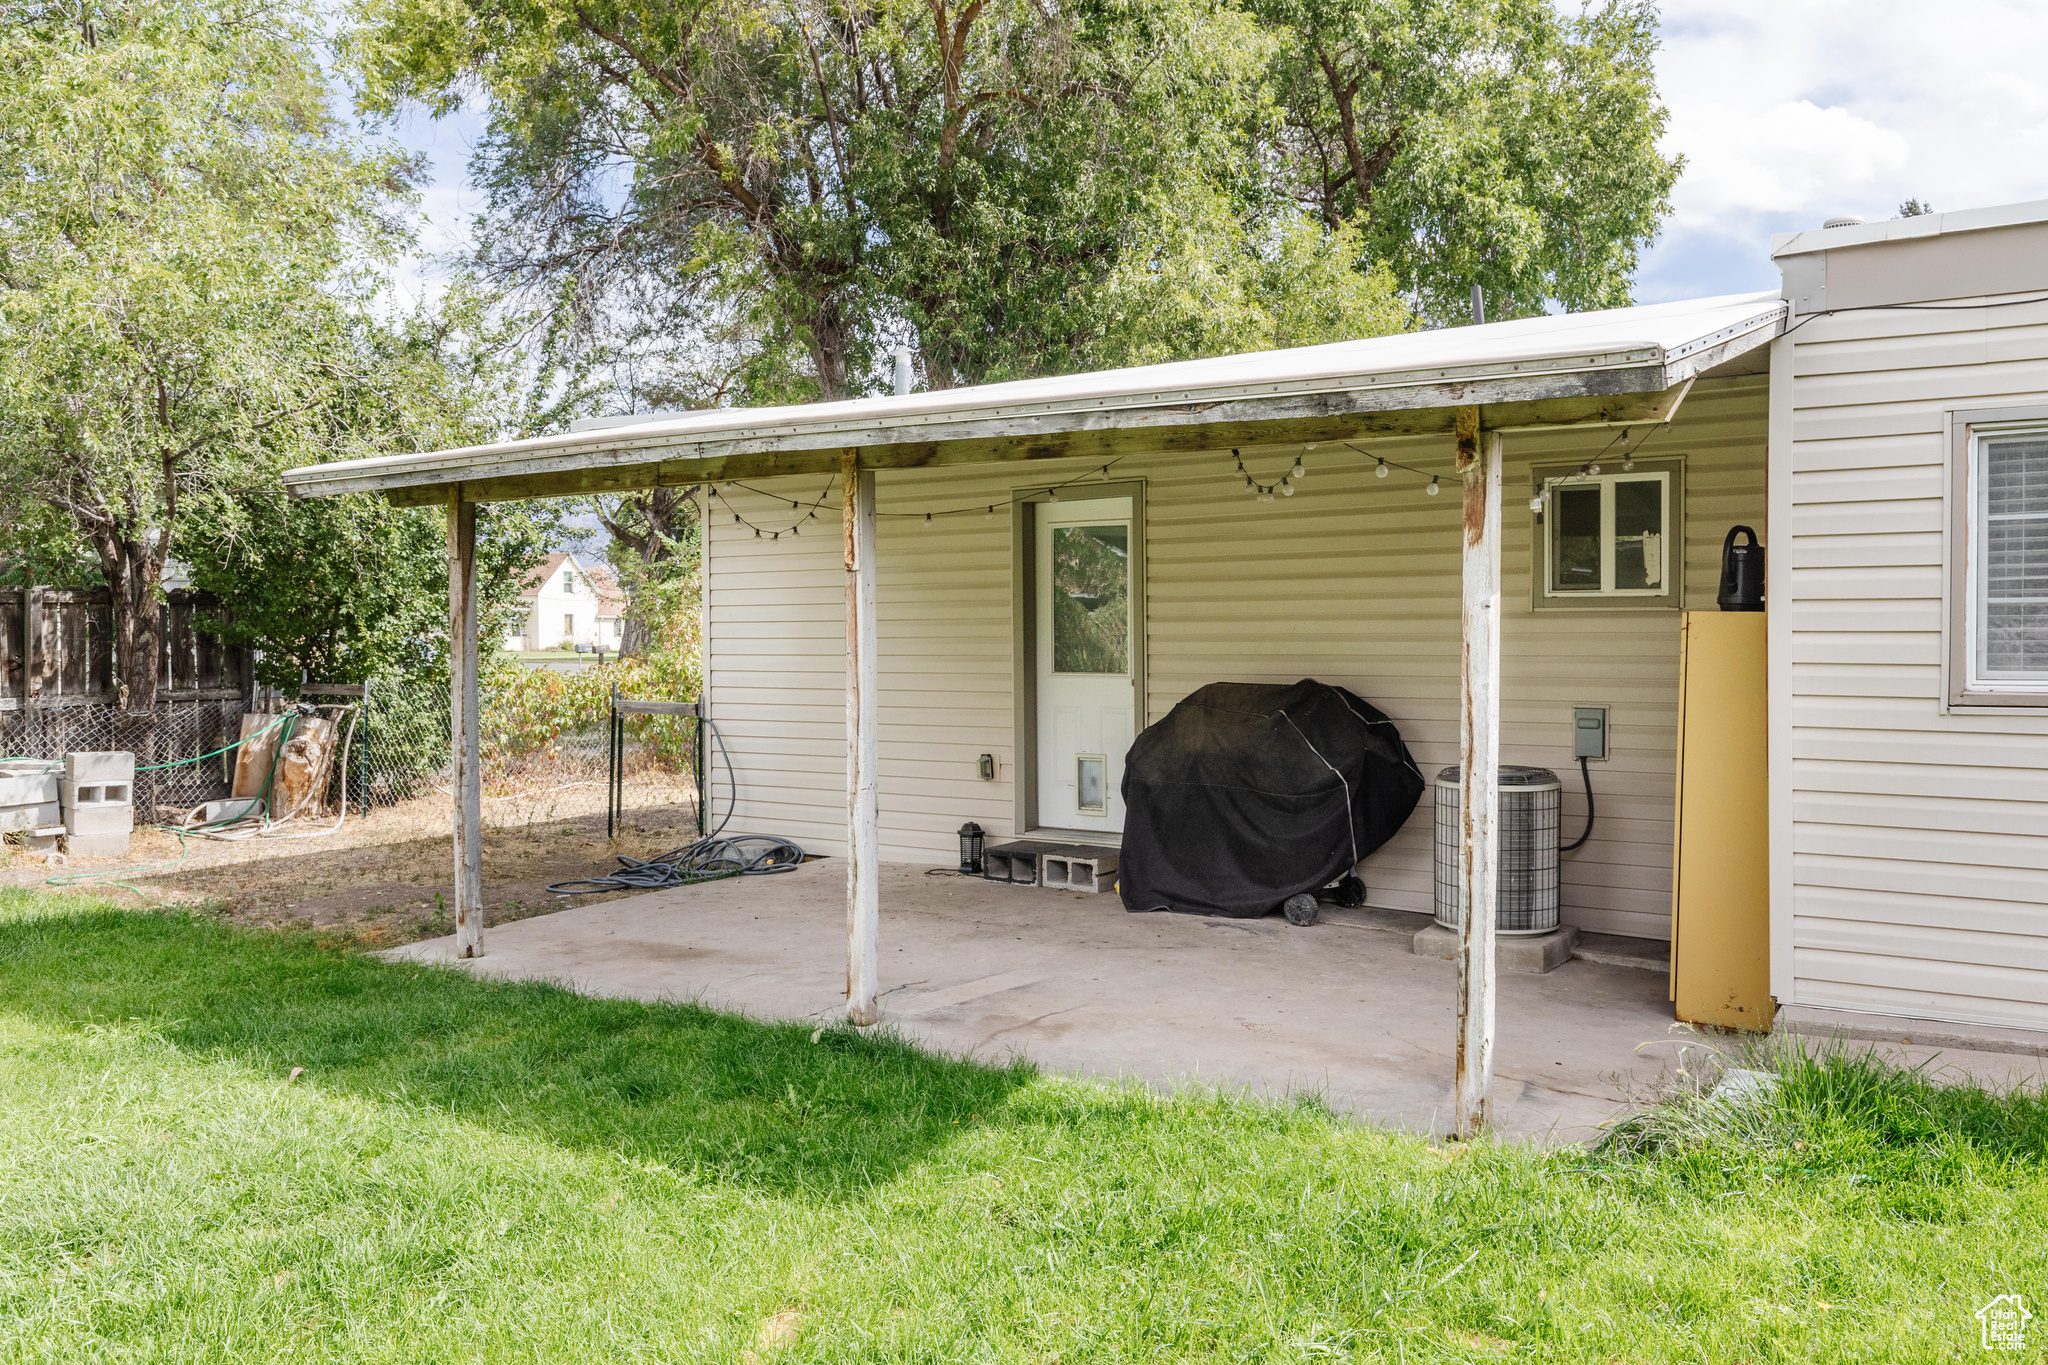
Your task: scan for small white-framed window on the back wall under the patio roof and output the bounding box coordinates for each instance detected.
[1534,469,1683,606]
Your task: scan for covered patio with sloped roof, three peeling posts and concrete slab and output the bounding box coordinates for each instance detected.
[287,295,1784,1138]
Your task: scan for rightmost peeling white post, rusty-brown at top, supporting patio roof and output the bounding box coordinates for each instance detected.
[1456,407,1501,1140]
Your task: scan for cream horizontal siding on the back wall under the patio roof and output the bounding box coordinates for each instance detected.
[707,377,1765,937]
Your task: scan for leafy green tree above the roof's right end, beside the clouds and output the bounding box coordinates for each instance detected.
[1251,0,1681,323]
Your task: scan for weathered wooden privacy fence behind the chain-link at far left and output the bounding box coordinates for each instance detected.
[0,587,252,712]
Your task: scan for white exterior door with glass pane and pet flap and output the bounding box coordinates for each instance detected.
[1032,497,1139,833]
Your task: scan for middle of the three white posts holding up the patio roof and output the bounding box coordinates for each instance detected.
[840,450,881,1025]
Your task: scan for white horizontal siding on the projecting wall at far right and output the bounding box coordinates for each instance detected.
[1772,290,2048,1029]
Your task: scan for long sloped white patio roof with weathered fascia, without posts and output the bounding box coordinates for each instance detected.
[285,293,1784,503]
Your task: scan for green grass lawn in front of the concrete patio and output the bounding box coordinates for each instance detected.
[0,892,2048,1365]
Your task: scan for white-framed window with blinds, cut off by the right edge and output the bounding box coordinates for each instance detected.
[1964,422,2048,704]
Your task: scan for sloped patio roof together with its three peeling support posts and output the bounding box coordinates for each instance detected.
[285,282,1786,1138]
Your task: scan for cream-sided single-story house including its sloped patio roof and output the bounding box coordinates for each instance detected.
[289,201,2048,1048]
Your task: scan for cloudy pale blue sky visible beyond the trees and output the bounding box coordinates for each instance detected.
[389,0,2048,313]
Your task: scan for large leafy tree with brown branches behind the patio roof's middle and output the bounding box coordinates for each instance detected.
[350,0,1407,405]
